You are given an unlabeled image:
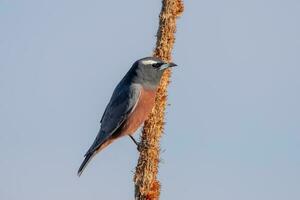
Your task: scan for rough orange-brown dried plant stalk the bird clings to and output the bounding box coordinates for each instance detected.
[134,0,184,200]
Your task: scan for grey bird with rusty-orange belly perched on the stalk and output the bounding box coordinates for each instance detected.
[77,57,177,176]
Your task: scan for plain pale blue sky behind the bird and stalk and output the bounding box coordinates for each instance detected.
[0,0,300,200]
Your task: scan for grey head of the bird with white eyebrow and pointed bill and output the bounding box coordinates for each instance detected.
[126,57,177,89]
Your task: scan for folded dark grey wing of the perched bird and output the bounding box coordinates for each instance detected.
[87,84,141,153]
